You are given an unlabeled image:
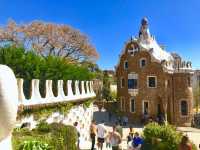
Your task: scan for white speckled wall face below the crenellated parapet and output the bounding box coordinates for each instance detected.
[17,104,93,148]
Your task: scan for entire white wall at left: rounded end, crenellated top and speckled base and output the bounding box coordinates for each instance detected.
[0,65,96,150]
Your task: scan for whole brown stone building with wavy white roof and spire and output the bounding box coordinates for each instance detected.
[116,18,193,126]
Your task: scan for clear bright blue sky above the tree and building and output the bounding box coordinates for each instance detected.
[0,0,200,69]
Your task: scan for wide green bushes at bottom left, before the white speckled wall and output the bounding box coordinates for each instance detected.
[12,123,77,150]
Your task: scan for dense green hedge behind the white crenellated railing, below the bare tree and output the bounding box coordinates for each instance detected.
[0,46,96,80]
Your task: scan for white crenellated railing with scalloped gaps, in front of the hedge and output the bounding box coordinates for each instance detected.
[17,78,96,106]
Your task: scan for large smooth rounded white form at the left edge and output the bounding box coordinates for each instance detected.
[0,65,18,150]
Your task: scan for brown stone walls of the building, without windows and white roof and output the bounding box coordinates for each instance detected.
[116,50,193,126]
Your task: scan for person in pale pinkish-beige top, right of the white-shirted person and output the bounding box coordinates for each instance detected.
[110,126,122,150]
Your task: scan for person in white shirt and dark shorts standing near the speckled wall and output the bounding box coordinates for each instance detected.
[97,121,106,150]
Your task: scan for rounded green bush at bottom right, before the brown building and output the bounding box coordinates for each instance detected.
[143,123,195,150]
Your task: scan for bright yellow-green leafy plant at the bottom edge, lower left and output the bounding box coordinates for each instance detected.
[19,141,51,150]
